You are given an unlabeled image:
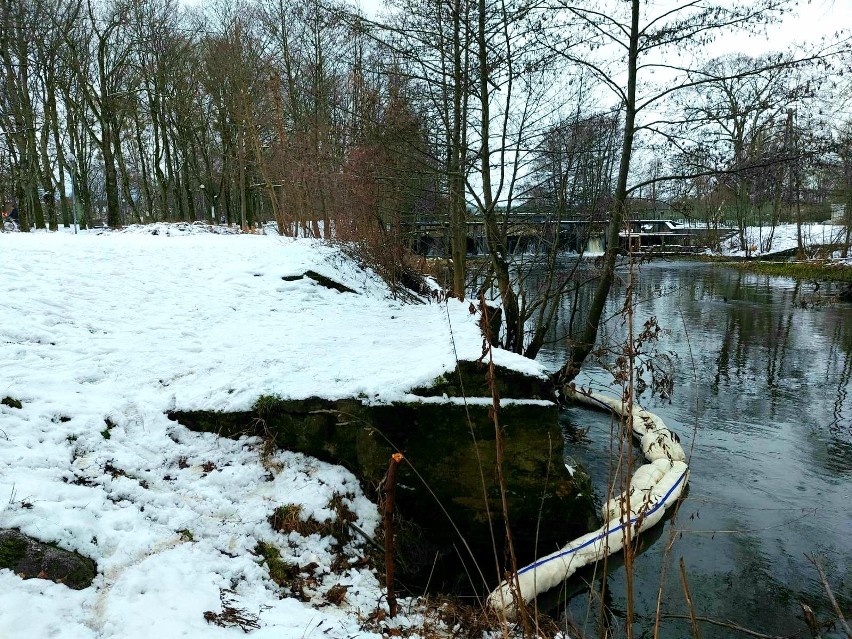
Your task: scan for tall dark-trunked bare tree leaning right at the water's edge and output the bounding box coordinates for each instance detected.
[541,0,808,384]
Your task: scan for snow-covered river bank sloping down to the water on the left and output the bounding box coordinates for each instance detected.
[0,225,542,639]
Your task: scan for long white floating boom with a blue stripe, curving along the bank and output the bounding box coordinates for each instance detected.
[488,389,689,617]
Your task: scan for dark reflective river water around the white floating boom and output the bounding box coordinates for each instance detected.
[542,263,852,639]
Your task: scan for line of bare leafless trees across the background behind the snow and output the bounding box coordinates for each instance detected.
[0,0,852,382]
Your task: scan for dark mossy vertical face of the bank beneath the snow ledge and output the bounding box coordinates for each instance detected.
[169,390,596,587]
